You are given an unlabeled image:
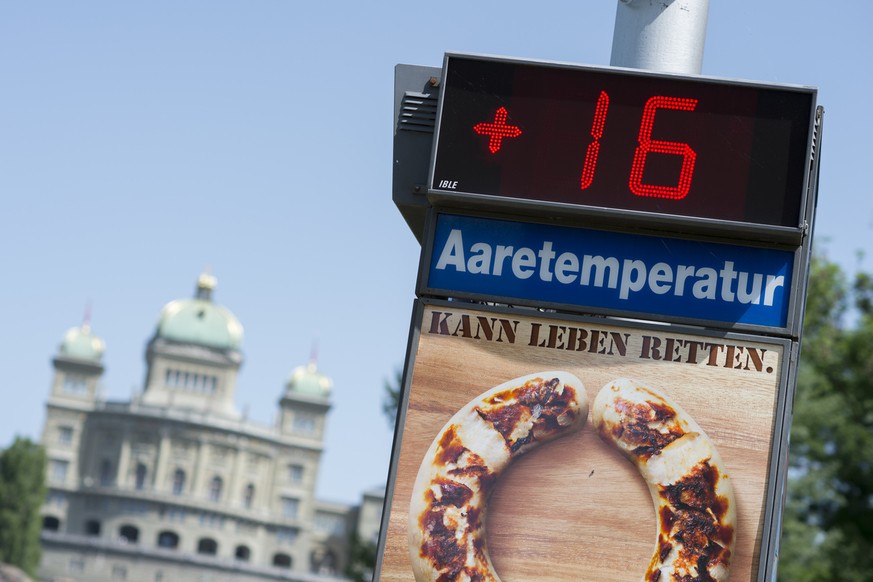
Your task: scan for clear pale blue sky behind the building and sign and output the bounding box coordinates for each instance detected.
[0,0,873,502]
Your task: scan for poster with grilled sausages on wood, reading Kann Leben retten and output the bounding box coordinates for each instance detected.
[377,302,790,582]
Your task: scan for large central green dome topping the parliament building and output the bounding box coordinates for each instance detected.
[157,274,243,350]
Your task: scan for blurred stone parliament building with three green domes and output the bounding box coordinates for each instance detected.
[40,275,382,582]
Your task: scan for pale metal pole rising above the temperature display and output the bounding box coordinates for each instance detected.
[610,0,709,75]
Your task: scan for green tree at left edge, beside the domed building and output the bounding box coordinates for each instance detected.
[0,437,46,575]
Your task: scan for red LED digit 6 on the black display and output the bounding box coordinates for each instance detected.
[629,95,697,200]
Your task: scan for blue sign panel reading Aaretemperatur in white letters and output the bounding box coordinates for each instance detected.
[425,214,794,327]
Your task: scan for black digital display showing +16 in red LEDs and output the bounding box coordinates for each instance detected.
[430,55,815,228]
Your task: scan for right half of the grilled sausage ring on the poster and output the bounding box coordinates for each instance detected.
[591,378,736,582]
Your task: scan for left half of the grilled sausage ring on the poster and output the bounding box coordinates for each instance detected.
[408,372,588,582]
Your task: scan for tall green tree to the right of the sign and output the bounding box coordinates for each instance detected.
[778,258,873,582]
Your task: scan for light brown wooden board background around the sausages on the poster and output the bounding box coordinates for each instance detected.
[379,307,783,582]
